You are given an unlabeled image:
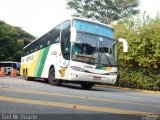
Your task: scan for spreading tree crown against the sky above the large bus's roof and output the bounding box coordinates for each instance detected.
[67,0,139,24]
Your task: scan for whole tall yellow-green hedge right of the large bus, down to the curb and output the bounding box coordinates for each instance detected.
[113,15,160,90]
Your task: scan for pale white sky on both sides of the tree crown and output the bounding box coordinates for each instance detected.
[0,0,160,37]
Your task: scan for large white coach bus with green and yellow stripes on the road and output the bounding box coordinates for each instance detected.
[20,17,128,89]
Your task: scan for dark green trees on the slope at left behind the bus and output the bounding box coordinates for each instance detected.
[0,21,34,61]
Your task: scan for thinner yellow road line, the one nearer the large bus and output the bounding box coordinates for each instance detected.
[0,87,160,108]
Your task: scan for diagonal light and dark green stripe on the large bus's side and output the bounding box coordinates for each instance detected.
[34,46,50,77]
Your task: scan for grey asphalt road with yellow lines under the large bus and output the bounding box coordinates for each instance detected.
[0,77,160,120]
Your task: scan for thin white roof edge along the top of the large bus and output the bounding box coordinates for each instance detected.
[23,17,112,49]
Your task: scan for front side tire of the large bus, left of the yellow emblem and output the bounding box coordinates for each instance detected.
[48,68,61,86]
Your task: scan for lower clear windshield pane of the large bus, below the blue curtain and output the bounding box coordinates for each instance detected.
[71,32,117,66]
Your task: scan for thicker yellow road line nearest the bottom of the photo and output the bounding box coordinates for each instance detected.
[0,96,155,115]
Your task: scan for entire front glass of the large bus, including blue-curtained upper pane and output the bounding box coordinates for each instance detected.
[71,19,117,66]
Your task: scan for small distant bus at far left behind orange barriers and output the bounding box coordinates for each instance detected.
[0,61,20,75]
